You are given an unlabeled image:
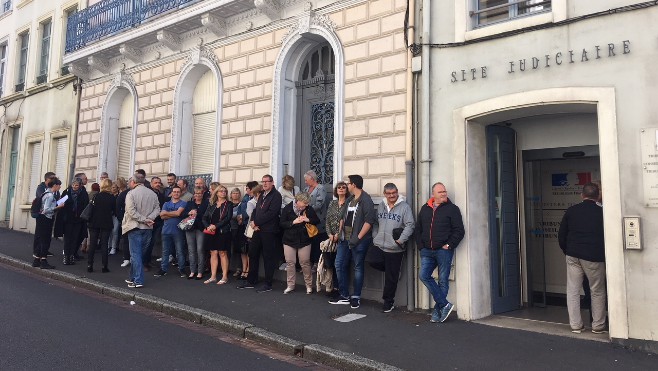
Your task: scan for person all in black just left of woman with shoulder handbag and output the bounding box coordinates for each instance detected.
[57,178,89,265]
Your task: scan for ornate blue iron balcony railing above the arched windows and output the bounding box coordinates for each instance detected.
[65,0,203,53]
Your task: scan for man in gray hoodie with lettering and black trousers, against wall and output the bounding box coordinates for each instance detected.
[370,183,414,313]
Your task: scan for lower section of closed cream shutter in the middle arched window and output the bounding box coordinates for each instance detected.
[192,112,217,174]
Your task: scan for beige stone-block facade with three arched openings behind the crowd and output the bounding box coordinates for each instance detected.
[64,0,409,303]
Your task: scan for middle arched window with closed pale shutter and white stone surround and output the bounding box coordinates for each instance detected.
[170,53,222,179]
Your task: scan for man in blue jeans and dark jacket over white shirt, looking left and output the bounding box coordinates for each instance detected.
[329,175,377,309]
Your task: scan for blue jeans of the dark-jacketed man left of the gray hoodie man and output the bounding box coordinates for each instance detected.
[335,237,372,298]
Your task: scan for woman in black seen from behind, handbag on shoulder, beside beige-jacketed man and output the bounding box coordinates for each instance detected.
[87,179,116,273]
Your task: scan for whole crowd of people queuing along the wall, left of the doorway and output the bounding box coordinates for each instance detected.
[34,170,464,322]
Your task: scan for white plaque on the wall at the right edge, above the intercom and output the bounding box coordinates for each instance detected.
[640,128,658,207]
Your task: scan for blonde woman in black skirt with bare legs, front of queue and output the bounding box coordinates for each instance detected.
[203,185,233,285]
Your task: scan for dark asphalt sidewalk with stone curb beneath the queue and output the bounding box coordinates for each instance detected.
[0,228,658,370]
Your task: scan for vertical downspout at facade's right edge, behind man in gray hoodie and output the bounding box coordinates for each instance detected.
[404,0,416,311]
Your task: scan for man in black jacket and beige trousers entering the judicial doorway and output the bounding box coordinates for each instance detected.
[558,183,606,334]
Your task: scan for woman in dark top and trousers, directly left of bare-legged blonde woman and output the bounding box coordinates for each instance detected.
[183,187,208,280]
